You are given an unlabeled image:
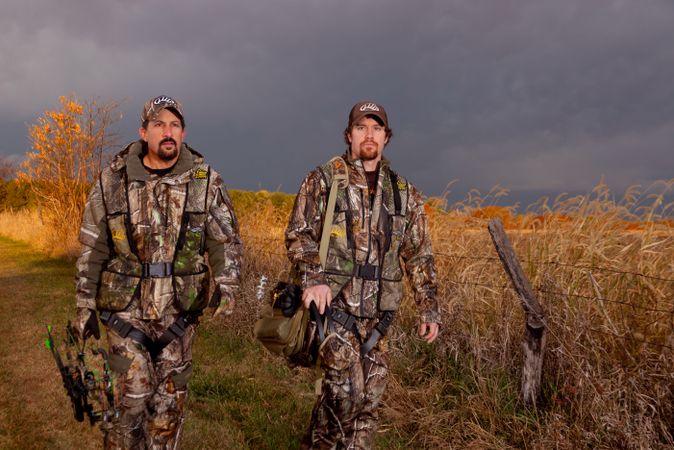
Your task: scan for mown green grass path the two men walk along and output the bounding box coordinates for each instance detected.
[0,238,313,449]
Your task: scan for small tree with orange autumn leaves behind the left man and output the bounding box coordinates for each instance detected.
[18,96,121,250]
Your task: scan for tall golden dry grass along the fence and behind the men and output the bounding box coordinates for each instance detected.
[0,182,674,448]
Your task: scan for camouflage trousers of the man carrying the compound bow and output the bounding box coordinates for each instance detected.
[103,314,196,449]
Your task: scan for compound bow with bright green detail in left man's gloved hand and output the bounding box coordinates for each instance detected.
[45,322,117,426]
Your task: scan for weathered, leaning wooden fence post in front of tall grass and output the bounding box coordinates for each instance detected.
[488,219,545,406]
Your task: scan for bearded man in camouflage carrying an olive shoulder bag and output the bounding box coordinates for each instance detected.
[286,101,440,449]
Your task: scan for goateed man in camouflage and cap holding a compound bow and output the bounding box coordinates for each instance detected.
[75,96,242,449]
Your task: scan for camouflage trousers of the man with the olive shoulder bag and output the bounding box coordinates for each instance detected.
[302,319,388,449]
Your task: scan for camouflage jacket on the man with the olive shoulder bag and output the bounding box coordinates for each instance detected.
[286,152,440,323]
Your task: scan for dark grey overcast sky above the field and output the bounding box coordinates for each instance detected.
[0,0,674,204]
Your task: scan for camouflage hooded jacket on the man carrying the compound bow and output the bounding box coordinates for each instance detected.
[76,141,242,320]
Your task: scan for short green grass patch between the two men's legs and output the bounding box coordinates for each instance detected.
[188,326,314,449]
